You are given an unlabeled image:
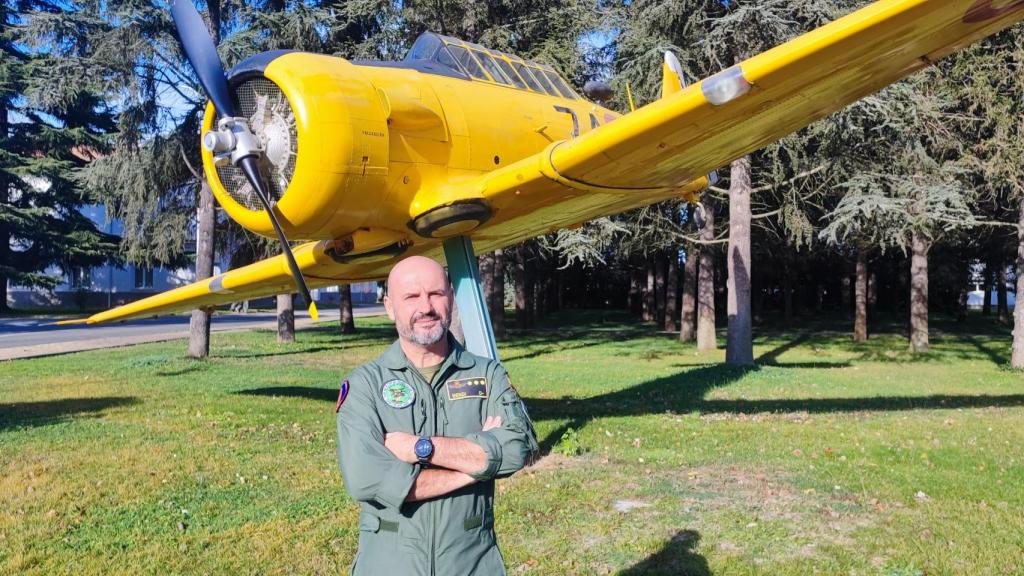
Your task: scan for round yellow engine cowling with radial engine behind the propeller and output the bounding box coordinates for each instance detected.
[203,52,388,240]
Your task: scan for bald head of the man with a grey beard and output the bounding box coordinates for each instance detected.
[384,256,452,346]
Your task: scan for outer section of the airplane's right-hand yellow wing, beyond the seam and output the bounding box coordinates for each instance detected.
[545,0,1024,191]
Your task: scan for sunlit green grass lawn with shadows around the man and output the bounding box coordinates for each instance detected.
[0,313,1024,576]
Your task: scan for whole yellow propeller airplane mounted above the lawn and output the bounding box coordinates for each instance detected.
[74,0,1024,324]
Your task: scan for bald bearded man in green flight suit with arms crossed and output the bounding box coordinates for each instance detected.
[337,256,538,576]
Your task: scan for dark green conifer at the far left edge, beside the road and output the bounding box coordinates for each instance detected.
[0,0,117,311]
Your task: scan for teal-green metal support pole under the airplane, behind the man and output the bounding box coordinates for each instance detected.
[444,236,498,360]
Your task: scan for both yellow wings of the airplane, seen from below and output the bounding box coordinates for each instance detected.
[72,0,1024,323]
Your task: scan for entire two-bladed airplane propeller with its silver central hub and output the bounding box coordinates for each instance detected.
[171,0,318,320]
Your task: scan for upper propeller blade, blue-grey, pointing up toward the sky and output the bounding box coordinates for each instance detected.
[171,0,234,118]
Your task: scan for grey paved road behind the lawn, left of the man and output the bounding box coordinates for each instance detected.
[0,304,384,360]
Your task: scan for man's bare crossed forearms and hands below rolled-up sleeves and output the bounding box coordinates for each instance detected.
[384,416,502,502]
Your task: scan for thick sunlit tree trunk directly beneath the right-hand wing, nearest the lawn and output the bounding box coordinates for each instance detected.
[725,156,754,366]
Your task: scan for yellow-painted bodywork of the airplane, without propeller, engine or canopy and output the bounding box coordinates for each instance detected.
[77,0,1024,323]
